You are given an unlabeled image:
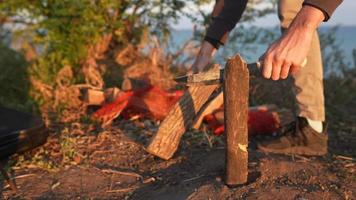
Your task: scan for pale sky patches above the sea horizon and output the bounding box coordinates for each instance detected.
[173,0,356,29]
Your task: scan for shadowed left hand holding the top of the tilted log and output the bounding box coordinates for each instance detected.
[192,41,216,73]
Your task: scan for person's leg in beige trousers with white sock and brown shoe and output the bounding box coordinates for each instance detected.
[258,0,328,156]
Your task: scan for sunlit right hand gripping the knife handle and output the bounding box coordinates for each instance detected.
[262,6,324,80]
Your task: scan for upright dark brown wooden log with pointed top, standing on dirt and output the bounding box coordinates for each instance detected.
[223,55,249,187]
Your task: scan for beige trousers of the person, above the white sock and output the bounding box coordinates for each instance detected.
[278,0,325,121]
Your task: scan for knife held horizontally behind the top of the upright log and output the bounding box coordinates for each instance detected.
[174,59,307,85]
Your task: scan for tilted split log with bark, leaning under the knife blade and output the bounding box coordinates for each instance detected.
[146,65,219,160]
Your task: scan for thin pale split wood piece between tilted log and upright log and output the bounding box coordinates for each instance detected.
[192,90,224,129]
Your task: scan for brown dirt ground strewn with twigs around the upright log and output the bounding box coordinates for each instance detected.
[0,116,356,200]
